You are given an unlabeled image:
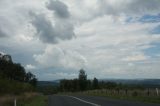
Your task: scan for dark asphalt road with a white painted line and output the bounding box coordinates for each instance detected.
[48,95,160,106]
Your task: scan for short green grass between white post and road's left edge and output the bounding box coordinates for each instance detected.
[17,95,47,106]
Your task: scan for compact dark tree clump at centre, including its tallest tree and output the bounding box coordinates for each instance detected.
[59,69,102,92]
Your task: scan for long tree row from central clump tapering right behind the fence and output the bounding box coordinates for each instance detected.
[59,69,143,92]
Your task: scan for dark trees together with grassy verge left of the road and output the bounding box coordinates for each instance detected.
[0,54,46,106]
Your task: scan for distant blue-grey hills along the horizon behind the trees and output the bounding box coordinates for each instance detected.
[38,79,160,87]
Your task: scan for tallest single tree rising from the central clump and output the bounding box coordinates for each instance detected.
[79,69,87,91]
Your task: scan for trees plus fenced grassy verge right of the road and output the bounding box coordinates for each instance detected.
[56,69,160,103]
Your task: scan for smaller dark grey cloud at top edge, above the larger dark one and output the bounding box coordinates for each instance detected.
[46,0,70,18]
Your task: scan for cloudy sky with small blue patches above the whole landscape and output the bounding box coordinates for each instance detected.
[0,0,160,80]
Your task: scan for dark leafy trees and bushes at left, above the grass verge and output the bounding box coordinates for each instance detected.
[0,53,37,93]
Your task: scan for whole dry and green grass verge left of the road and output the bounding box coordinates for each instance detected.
[0,93,47,106]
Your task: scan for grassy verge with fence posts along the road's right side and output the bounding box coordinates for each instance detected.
[71,89,160,104]
